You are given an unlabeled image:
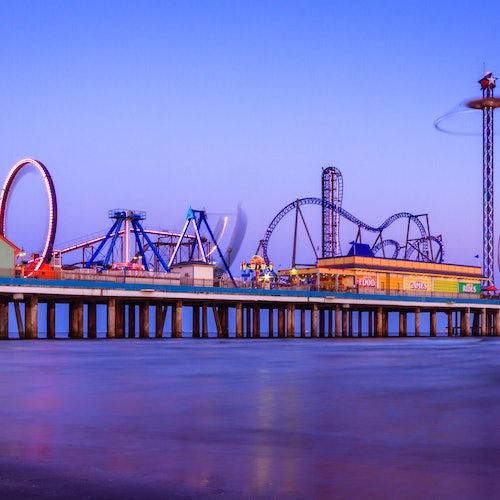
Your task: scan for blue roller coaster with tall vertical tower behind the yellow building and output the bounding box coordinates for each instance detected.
[257,167,444,268]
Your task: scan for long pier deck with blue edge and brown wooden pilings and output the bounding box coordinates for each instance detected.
[0,278,500,339]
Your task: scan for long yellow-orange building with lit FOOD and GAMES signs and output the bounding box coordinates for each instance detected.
[279,255,484,295]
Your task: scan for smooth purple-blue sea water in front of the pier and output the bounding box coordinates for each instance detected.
[0,338,500,499]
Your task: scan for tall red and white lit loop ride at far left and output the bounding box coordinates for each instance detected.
[0,158,57,271]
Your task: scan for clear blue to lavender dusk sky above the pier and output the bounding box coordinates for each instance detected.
[0,0,500,274]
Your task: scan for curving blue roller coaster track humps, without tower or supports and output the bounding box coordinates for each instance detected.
[261,198,443,263]
